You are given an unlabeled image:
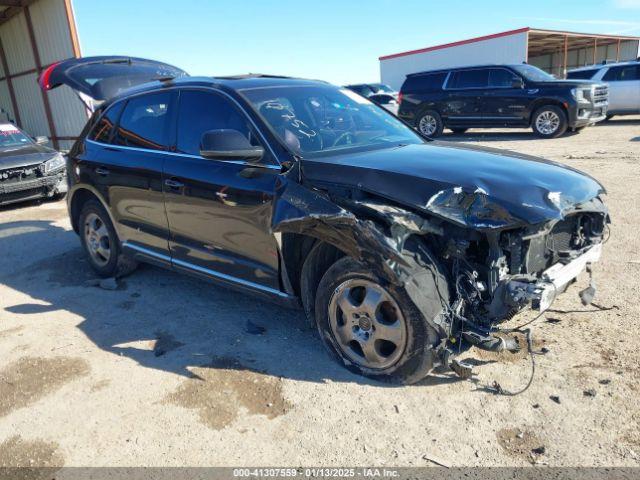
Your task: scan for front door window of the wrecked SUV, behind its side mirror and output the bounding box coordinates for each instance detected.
[177,90,258,155]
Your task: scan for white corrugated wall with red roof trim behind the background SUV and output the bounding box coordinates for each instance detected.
[380,32,527,90]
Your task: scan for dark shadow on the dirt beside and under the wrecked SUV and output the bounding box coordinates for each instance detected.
[0,221,459,386]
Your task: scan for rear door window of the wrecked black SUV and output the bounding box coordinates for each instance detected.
[115,92,171,150]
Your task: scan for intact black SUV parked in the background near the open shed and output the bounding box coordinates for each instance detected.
[398,64,608,138]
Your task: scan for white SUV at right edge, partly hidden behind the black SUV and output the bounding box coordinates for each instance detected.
[567,61,640,118]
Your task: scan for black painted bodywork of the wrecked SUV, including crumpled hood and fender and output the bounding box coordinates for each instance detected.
[46,59,606,372]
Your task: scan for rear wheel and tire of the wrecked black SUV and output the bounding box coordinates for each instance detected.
[78,200,138,278]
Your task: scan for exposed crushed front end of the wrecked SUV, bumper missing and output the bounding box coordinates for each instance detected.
[424,193,610,362]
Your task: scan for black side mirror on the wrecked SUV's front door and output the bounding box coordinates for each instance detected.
[200,129,264,162]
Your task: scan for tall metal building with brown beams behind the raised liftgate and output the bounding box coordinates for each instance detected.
[0,0,88,149]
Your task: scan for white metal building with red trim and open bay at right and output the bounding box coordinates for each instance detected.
[379,27,640,90]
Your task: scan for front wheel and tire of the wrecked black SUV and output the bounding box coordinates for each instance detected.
[315,257,442,384]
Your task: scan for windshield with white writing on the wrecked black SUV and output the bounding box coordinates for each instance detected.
[242,85,424,157]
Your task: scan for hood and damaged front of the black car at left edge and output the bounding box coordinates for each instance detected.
[0,142,66,205]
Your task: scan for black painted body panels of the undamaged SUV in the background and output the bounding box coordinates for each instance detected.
[398,65,604,128]
